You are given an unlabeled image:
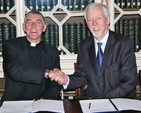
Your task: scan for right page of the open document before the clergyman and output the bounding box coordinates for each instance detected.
[32,100,64,113]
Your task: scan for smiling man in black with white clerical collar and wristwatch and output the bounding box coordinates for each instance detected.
[1,11,62,101]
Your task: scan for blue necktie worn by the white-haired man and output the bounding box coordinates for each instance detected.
[97,42,103,75]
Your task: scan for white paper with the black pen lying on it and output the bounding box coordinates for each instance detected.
[79,99,117,113]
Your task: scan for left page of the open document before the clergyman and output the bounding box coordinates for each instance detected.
[0,101,33,113]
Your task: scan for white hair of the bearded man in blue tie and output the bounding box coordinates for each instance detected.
[84,3,110,21]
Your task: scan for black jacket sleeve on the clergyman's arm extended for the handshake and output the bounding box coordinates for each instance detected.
[2,41,44,84]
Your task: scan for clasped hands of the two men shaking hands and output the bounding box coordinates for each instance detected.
[49,68,68,85]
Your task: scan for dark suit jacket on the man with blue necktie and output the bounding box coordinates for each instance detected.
[67,31,137,98]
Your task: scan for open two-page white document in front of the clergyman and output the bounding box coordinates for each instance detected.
[0,100,64,113]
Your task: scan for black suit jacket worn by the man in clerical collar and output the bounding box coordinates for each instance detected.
[2,37,61,100]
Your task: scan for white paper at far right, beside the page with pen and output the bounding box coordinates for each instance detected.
[111,98,141,111]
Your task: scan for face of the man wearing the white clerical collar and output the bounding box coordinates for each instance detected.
[23,14,46,43]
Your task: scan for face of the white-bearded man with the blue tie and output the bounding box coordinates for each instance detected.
[87,7,110,40]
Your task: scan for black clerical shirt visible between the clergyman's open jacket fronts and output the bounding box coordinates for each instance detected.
[21,40,42,100]
